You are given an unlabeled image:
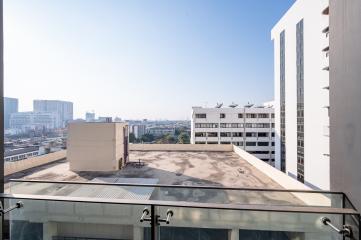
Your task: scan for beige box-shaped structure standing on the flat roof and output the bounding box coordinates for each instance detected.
[67,122,128,171]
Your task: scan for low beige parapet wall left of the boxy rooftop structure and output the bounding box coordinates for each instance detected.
[4,150,66,176]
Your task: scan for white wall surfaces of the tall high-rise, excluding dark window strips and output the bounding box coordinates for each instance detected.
[271,0,330,190]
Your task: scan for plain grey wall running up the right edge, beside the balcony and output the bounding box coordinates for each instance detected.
[330,0,361,210]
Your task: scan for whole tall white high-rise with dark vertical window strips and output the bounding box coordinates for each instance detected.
[271,0,330,190]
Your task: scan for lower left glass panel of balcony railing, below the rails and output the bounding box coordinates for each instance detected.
[7,199,150,240]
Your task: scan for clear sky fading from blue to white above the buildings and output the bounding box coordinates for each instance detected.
[4,0,294,120]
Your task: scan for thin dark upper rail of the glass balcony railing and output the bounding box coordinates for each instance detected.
[9,179,344,195]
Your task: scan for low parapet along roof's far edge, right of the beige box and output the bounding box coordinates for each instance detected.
[129,144,233,152]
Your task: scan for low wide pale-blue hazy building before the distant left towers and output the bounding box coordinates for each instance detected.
[10,112,59,131]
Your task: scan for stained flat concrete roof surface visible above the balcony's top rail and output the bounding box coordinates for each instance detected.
[7,151,281,189]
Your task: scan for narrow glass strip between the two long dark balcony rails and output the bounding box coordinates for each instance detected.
[10,182,343,208]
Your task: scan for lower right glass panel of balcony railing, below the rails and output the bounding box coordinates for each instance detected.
[158,207,342,240]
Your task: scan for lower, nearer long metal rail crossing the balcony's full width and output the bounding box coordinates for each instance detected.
[0,194,360,216]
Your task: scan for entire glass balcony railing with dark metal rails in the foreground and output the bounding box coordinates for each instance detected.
[2,181,360,240]
